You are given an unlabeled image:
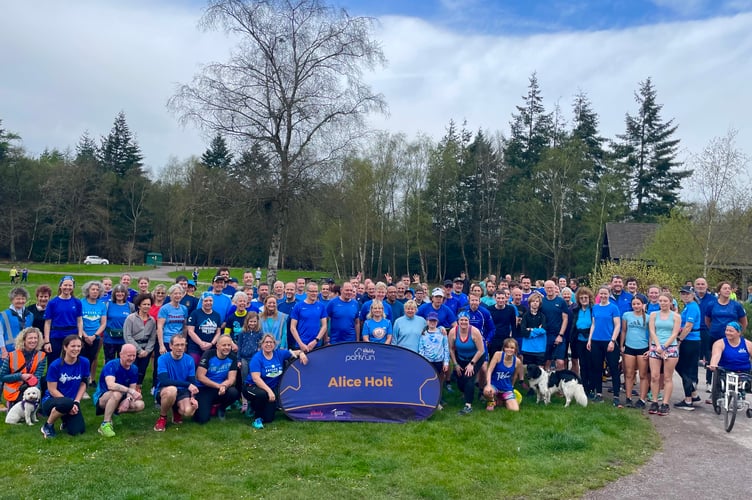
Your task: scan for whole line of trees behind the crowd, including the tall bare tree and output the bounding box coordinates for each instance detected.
[0,0,747,280]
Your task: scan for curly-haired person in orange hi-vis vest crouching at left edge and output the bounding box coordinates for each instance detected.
[0,327,46,408]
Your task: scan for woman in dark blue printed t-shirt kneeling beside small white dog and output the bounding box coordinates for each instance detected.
[40,334,89,439]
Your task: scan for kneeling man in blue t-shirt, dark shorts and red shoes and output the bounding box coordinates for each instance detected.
[154,333,198,432]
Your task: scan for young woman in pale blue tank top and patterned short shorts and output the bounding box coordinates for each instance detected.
[648,292,681,416]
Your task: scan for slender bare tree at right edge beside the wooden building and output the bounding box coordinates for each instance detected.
[691,129,749,276]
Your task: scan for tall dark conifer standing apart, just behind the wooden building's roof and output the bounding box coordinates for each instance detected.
[615,78,691,222]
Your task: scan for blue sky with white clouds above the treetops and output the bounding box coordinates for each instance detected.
[0,0,752,173]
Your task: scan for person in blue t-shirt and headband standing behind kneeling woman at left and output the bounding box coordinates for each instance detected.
[42,276,83,370]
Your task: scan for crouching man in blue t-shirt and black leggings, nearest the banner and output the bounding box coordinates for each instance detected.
[193,335,240,424]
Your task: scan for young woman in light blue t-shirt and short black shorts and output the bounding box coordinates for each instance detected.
[621,295,650,409]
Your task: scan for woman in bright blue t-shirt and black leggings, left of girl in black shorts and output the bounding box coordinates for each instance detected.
[585,286,621,407]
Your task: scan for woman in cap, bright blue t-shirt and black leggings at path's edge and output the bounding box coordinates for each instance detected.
[674,285,701,411]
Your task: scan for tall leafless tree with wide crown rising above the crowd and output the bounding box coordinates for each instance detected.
[168,0,386,281]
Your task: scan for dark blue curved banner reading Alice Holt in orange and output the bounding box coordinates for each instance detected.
[279,342,441,422]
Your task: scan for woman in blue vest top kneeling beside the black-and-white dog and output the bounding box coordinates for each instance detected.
[483,338,524,411]
